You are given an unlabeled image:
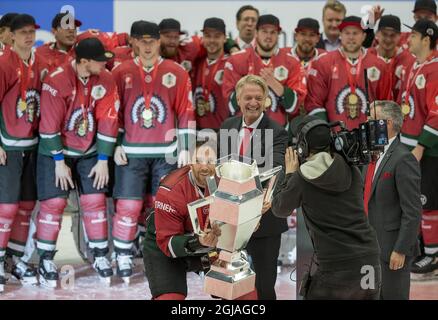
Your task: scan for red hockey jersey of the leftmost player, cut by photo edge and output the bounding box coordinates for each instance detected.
[0,48,49,150]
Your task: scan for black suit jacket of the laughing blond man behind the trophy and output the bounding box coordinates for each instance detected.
[218,114,288,238]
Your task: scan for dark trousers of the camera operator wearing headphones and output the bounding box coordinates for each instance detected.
[305,265,382,300]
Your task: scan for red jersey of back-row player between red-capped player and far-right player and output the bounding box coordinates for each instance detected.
[368,46,415,100]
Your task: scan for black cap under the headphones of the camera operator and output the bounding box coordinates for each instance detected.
[290,115,331,150]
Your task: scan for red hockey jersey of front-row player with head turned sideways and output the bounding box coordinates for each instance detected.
[39,61,120,157]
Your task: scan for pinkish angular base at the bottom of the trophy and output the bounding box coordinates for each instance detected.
[204,270,255,300]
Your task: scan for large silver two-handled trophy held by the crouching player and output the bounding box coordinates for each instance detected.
[187,155,281,300]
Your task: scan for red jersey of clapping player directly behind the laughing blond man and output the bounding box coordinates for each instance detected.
[222,48,306,126]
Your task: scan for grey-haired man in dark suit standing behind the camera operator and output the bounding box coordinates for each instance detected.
[364,101,422,300]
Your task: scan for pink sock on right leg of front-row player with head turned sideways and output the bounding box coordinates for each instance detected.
[80,193,108,244]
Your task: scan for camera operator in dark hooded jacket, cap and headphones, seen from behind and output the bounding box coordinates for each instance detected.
[272,116,381,299]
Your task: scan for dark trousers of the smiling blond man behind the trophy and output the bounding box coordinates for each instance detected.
[246,234,281,300]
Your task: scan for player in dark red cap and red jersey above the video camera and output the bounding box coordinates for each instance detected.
[304,16,391,129]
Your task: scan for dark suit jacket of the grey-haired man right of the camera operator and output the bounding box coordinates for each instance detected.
[364,138,422,262]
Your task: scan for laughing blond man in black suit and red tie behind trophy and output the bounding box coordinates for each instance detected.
[218,75,288,300]
